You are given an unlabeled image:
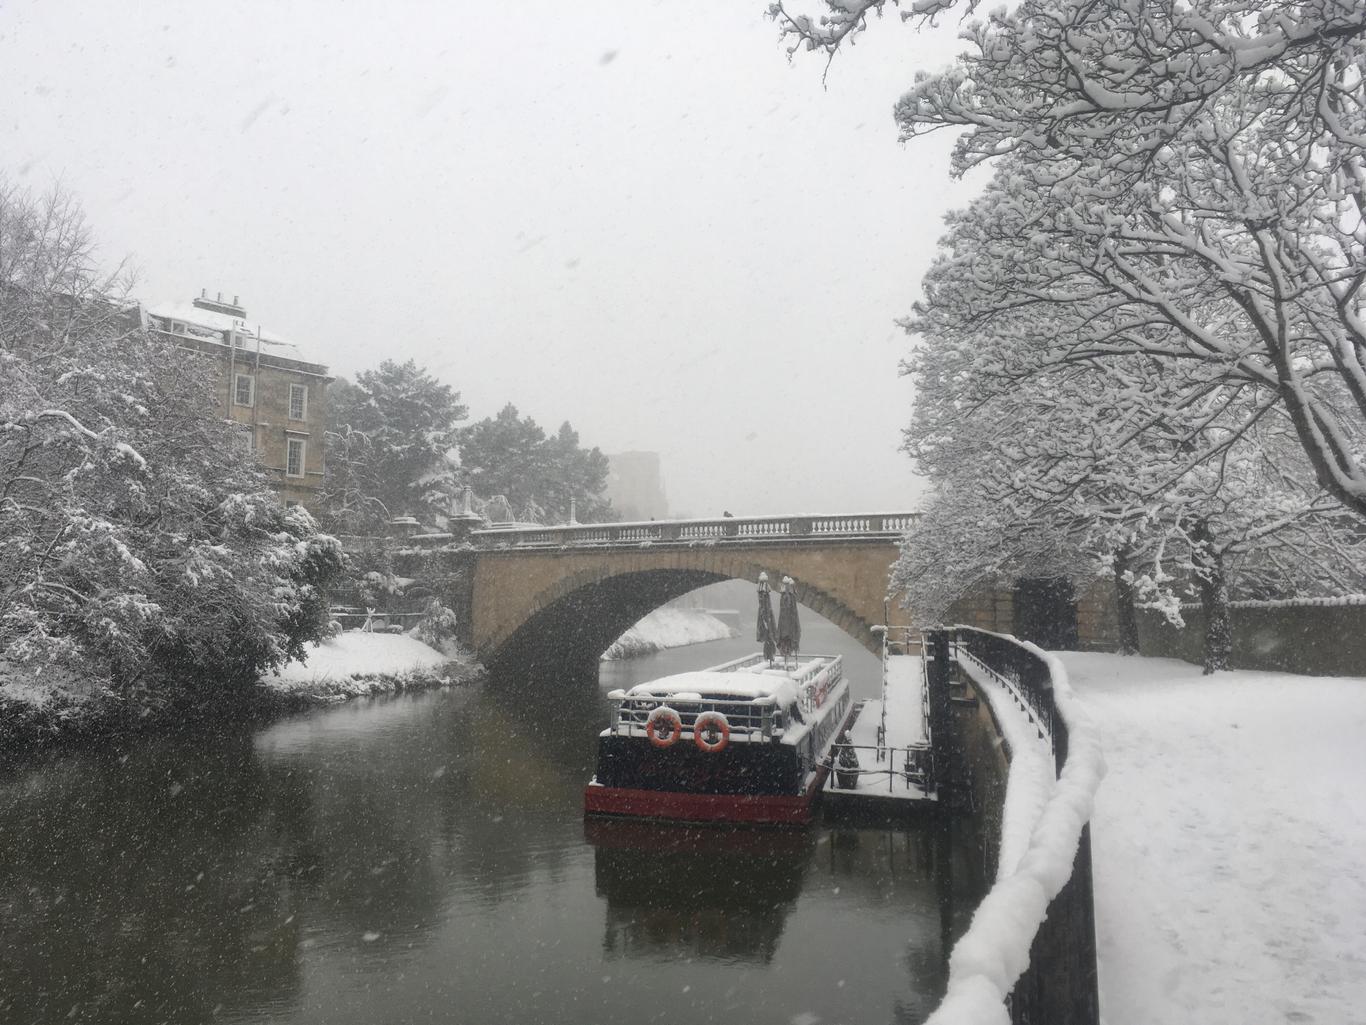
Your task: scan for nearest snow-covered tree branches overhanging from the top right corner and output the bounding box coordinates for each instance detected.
[773,0,1366,515]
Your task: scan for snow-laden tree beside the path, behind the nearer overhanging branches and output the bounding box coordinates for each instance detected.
[899,181,1362,675]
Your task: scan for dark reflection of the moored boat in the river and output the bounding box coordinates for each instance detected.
[583,817,816,965]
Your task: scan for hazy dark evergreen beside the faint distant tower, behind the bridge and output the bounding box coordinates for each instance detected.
[460,403,612,523]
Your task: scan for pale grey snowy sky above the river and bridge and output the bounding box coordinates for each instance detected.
[0,0,979,517]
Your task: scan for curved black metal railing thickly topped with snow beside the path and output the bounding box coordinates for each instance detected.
[928,627,1105,1025]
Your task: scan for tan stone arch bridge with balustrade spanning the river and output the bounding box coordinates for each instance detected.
[464,513,914,675]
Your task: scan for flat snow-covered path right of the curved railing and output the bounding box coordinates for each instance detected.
[1059,652,1366,1025]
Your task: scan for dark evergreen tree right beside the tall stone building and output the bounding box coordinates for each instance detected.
[322,359,469,533]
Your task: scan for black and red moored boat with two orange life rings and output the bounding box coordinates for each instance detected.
[583,655,852,825]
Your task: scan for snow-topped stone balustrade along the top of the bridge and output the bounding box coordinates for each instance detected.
[470,513,917,548]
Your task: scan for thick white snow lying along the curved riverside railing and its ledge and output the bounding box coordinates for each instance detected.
[926,644,1105,1025]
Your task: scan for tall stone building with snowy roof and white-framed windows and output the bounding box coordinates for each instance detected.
[142,292,332,511]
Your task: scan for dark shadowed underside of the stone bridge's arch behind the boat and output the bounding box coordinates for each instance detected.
[486,569,880,683]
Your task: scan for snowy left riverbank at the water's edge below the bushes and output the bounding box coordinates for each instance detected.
[0,633,484,757]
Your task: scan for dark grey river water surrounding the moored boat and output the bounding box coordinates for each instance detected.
[0,615,981,1025]
